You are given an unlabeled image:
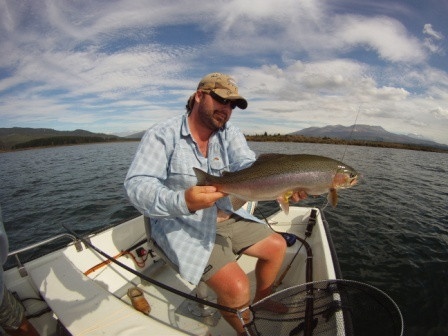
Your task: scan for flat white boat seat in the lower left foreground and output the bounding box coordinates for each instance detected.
[27,252,177,335]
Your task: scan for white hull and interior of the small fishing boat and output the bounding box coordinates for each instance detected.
[5,207,338,335]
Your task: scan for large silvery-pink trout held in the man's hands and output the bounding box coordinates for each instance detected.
[193,153,358,214]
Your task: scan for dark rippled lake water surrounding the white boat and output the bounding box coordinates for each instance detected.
[0,142,448,335]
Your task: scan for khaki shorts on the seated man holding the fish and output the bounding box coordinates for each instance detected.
[201,216,273,281]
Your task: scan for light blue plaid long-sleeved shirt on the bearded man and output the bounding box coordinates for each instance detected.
[124,115,259,284]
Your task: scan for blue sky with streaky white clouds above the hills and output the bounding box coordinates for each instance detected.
[0,0,448,144]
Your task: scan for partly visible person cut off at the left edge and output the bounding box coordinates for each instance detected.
[0,207,39,336]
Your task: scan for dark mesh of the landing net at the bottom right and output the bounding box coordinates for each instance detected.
[245,279,403,336]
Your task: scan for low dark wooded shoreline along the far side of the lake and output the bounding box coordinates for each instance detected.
[0,134,448,153]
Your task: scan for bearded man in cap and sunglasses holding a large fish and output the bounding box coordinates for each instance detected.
[124,73,303,333]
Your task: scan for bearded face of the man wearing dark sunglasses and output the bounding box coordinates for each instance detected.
[198,92,233,131]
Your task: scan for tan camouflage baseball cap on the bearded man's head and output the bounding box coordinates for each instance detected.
[198,72,247,110]
